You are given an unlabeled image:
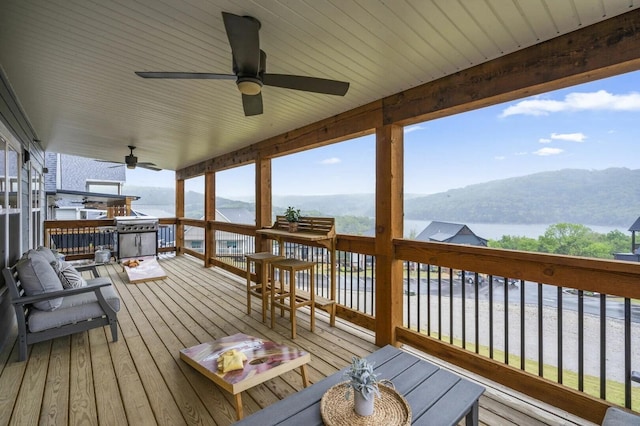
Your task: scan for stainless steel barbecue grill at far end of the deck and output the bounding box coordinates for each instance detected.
[116,216,158,259]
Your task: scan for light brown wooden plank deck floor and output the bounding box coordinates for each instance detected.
[0,256,585,425]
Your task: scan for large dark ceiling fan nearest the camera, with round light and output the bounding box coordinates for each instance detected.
[136,12,349,116]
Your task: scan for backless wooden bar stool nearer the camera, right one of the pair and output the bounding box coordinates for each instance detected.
[271,259,316,339]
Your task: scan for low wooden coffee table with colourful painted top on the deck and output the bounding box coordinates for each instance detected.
[180,333,311,420]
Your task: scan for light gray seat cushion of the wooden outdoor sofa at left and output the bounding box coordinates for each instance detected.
[29,277,120,333]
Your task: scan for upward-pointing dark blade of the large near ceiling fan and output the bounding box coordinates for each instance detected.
[222,12,260,77]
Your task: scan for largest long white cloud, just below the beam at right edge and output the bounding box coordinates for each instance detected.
[500,90,640,117]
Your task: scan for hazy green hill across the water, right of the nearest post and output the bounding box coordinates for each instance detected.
[405,168,640,226]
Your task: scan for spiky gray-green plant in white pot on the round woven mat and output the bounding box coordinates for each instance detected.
[344,356,380,416]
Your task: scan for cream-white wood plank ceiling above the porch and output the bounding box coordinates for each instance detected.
[0,0,640,170]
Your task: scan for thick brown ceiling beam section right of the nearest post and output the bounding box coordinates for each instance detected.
[383,9,640,125]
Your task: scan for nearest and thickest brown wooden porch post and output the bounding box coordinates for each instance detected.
[375,125,404,346]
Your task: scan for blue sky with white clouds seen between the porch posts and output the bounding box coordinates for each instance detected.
[127,72,640,198]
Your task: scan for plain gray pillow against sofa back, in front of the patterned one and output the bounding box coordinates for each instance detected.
[16,256,64,311]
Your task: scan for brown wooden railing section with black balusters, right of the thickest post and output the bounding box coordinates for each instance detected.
[394,240,640,421]
